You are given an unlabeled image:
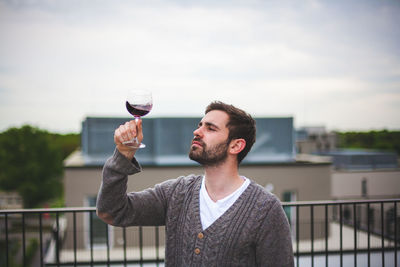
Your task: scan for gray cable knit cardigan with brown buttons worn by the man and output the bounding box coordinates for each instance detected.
[97,150,294,267]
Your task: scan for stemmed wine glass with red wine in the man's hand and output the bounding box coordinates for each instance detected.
[123,90,153,148]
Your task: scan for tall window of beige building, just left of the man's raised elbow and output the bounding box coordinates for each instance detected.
[84,196,113,248]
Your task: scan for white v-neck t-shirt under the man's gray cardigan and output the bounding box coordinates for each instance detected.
[200,176,250,230]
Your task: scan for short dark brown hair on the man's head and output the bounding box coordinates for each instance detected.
[205,101,256,164]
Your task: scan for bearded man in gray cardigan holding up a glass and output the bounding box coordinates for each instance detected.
[97,102,294,267]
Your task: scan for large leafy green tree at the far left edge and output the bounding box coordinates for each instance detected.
[0,125,63,208]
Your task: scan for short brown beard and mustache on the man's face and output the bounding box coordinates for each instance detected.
[189,140,229,167]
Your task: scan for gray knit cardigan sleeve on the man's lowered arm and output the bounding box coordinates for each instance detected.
[256,199,294,267]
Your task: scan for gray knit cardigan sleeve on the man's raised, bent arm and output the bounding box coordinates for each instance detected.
[96,150,179,226]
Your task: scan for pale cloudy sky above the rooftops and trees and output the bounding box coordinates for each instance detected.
[0,0,400,133]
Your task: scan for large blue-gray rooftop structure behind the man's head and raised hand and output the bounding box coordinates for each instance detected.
[65,117,296,167]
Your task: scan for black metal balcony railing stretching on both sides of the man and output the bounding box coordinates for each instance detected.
[0,199,400,267]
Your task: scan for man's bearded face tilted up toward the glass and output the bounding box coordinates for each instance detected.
[189,110,229,167]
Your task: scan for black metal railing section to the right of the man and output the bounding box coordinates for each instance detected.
[284,199,400,267]
